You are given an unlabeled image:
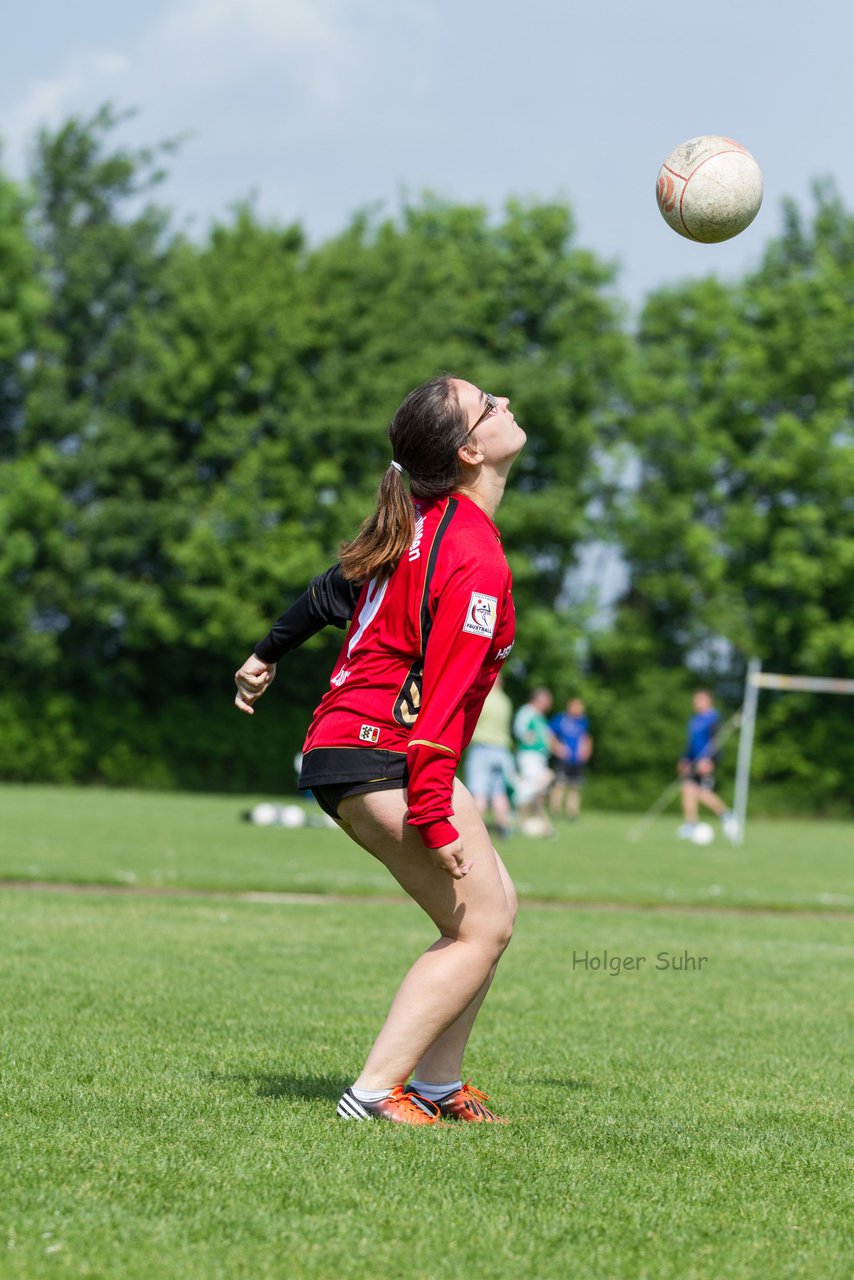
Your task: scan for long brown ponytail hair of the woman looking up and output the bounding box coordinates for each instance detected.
[341,374,469,582]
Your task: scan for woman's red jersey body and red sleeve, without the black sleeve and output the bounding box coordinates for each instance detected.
[303,495,515,849]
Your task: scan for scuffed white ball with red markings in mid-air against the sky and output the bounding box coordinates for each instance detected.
[656,134,762,244]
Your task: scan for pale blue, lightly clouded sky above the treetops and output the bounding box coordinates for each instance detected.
[0,0,854,303]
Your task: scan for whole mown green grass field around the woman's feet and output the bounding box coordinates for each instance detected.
[0,788,854,1280]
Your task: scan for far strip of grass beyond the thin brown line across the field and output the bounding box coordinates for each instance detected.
[0,786,854,911]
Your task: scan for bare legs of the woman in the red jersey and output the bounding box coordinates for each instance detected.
[339,783,516,1089]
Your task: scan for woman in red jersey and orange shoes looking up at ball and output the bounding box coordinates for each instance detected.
[234,378,525,1124]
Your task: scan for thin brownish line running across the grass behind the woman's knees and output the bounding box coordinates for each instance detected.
[0,879,854,920]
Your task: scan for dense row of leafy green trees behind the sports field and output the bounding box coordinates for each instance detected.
[0,108,854,812]
